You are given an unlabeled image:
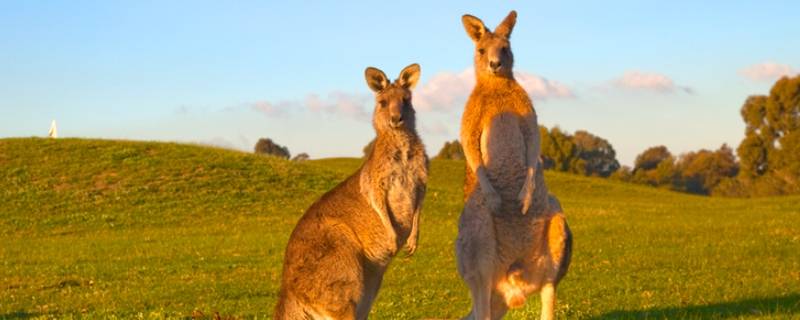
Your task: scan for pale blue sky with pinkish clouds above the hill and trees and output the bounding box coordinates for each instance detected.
[0,1,800,164]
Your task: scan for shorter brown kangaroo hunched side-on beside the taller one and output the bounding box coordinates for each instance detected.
[274,64,428,319]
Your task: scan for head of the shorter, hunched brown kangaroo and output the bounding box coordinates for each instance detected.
[364,63,420,132]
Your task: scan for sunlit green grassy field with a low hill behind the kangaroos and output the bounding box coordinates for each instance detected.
[0,138,800,319]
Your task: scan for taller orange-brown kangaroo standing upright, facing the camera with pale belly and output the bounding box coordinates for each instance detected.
[456,11,572,320]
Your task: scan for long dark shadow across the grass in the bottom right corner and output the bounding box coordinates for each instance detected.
[592,294,800,319]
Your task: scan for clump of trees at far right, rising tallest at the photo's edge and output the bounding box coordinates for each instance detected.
[620,75,800,197]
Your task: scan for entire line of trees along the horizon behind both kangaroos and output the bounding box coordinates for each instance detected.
[256,75,800,197]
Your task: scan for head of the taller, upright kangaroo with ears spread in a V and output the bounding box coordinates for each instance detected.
[461,10,517,78]
